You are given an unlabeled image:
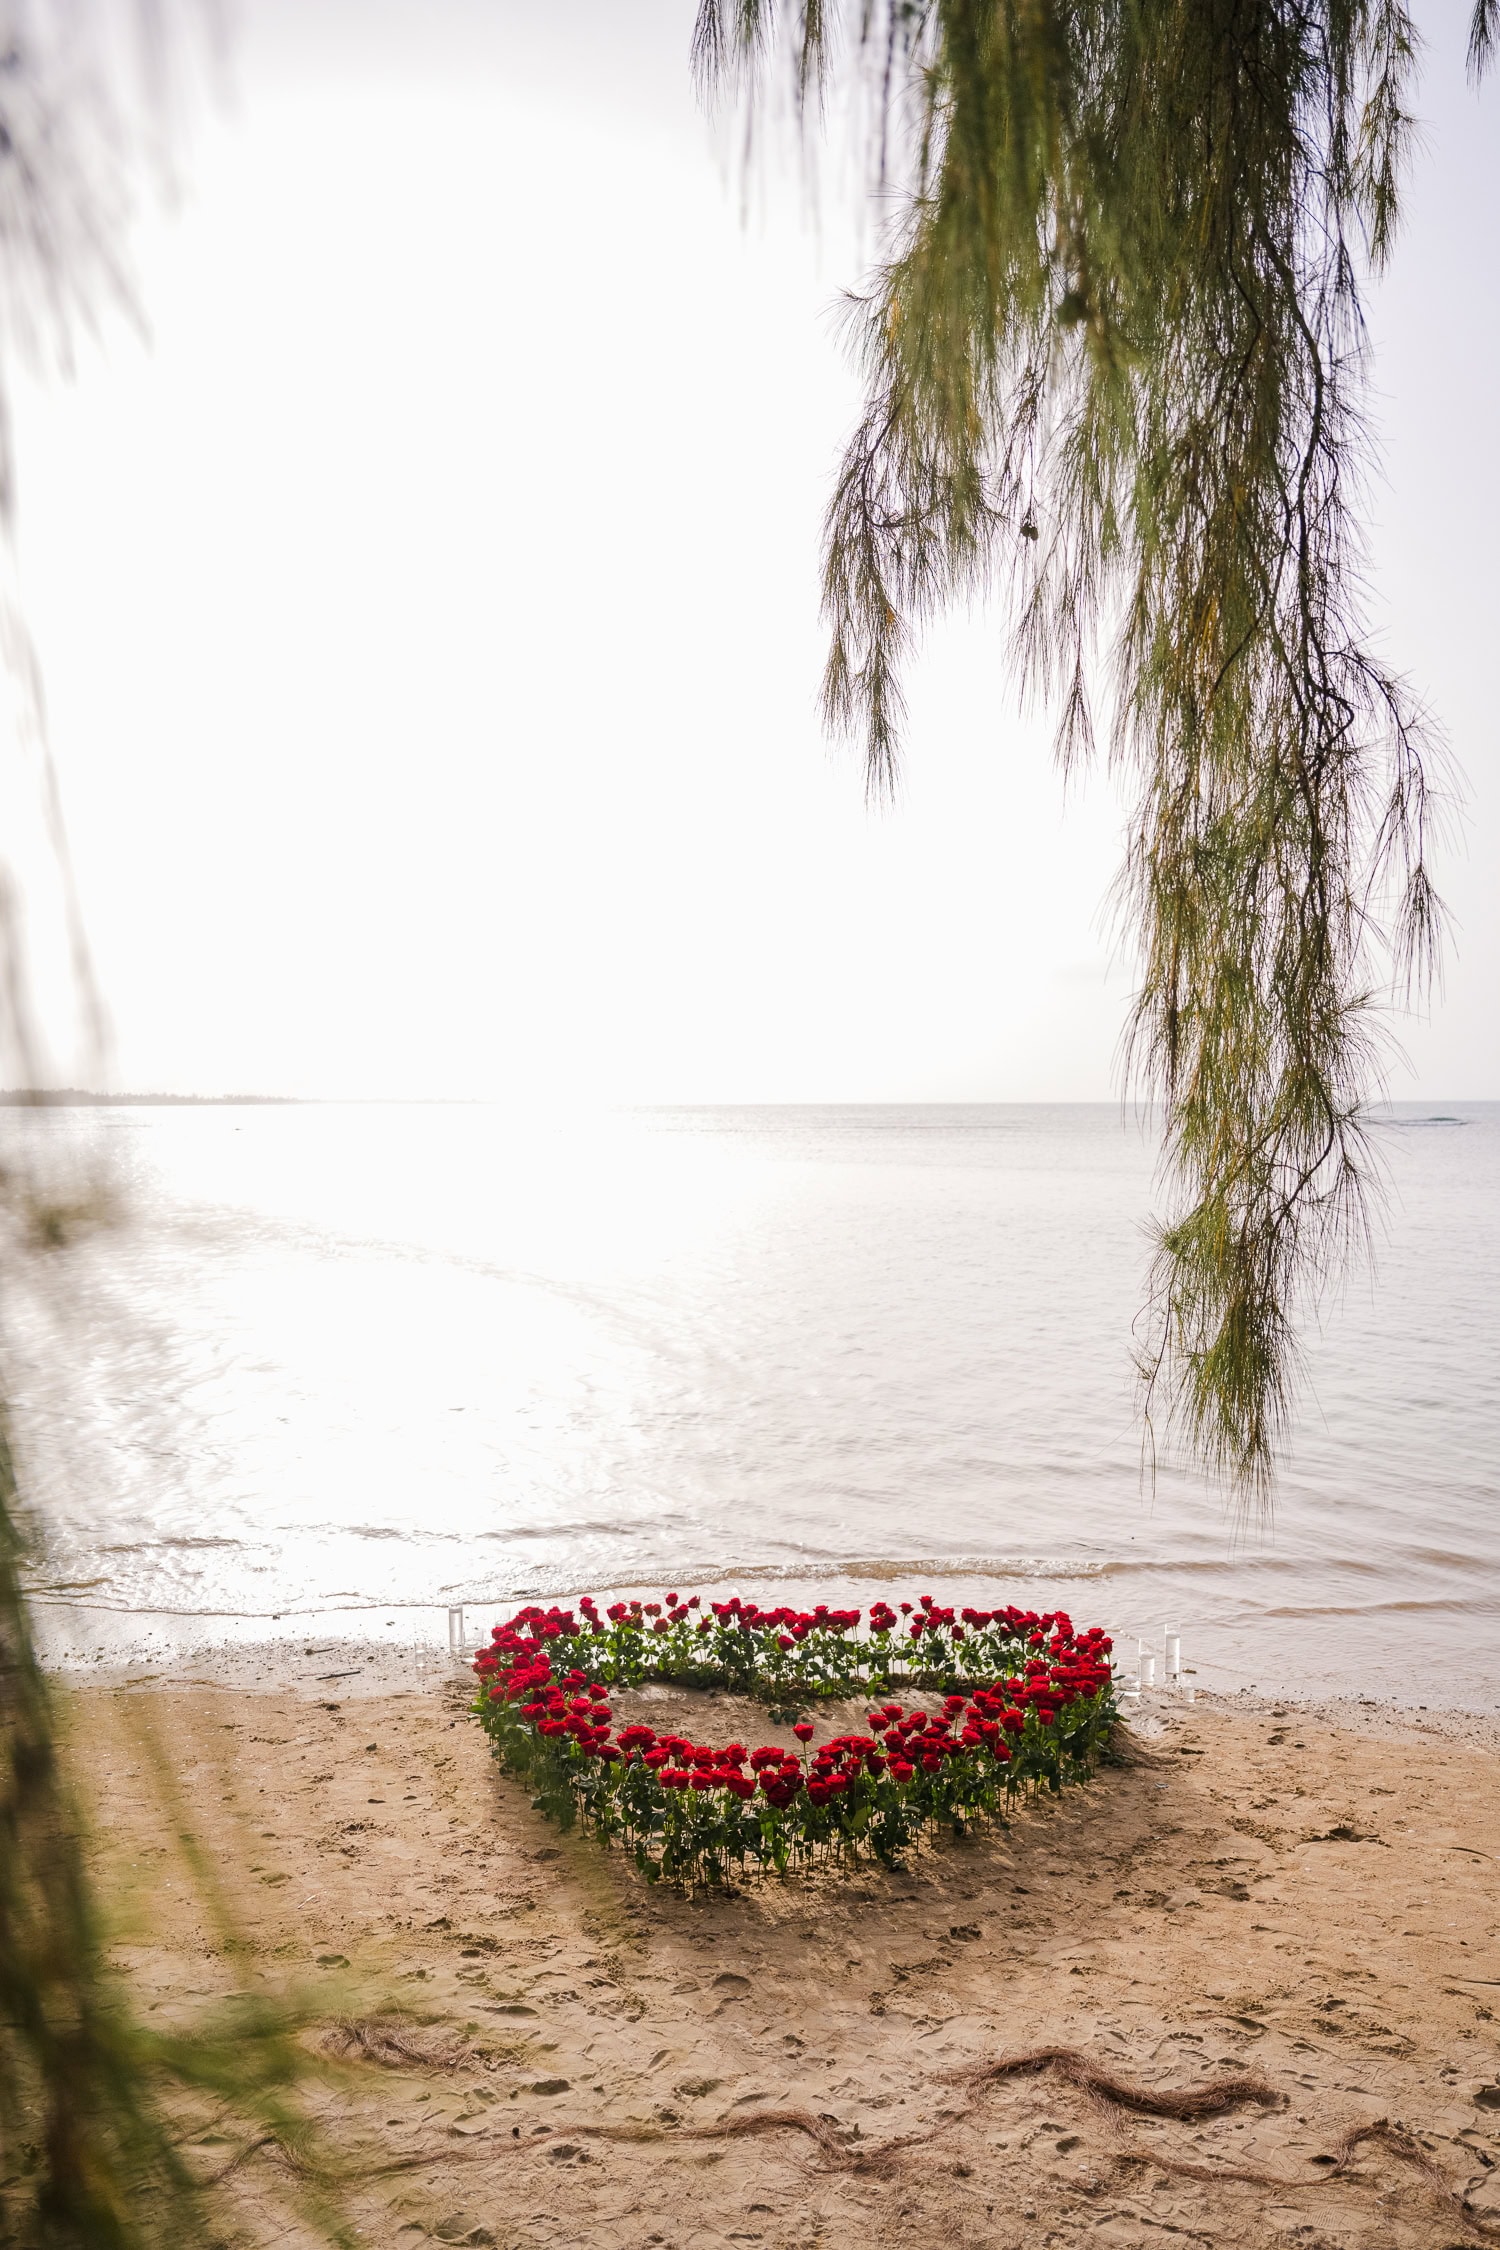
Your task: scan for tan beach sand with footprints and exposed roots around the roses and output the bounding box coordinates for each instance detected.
[65,1652,1500,2250]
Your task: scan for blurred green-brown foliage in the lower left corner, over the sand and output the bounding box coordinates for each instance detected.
[0,1395,364,2250]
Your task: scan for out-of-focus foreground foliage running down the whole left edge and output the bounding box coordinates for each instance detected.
[0,13,349,2250]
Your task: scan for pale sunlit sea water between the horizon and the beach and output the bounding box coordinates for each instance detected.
[2,1103,1500,1708]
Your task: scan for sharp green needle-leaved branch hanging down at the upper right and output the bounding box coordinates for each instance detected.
[695,0,1457,1494]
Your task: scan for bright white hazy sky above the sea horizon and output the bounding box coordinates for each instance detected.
[5,0,1500,1103]
